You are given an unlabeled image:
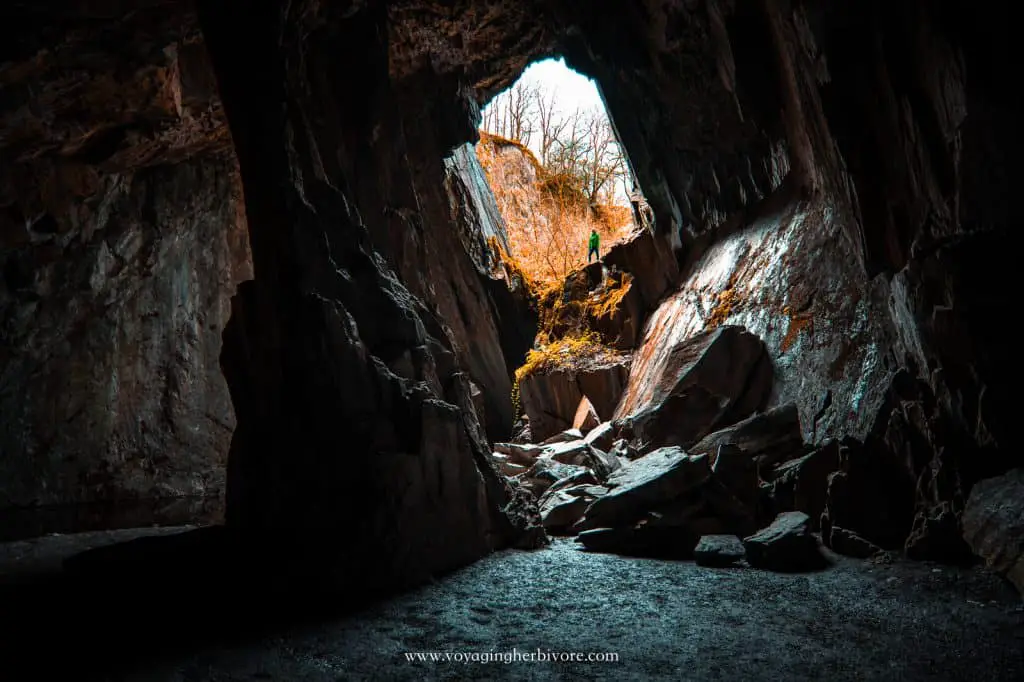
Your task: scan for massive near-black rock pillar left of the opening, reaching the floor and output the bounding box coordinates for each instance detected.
[194,2,537,590]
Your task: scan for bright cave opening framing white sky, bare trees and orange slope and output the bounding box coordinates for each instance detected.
[476,57,649,285]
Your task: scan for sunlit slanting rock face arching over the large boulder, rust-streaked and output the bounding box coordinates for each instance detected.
[618,204,892,442]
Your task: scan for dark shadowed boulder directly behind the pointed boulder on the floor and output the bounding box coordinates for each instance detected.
[768,440,839,528]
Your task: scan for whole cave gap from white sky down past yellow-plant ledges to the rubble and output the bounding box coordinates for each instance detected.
[476,57,653,442]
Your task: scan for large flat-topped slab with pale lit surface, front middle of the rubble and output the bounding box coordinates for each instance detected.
[580,447,711,530]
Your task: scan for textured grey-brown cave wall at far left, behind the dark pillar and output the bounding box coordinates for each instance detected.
[0,1,250,538]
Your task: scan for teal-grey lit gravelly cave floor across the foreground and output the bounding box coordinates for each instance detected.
[9,540,1024,682]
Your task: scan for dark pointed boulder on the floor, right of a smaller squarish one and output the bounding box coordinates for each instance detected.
[743,512,826,571]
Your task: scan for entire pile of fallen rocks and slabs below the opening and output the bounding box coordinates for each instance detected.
[494,327,876,570]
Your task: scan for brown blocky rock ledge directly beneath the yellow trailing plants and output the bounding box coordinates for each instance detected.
[519,355,630,440]
